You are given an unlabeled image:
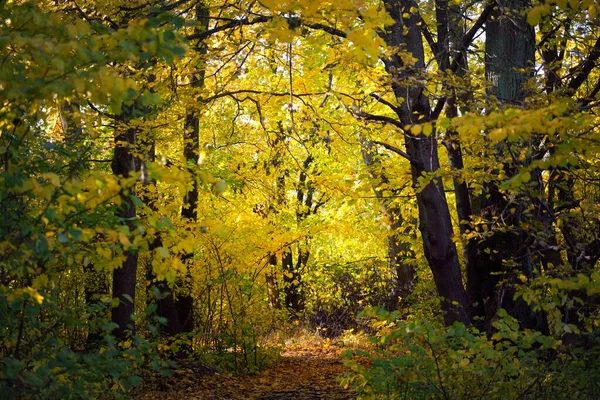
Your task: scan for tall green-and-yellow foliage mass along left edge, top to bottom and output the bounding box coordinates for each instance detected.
[0,2,183,398]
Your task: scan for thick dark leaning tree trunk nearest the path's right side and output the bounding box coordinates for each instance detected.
[383,0,470,324]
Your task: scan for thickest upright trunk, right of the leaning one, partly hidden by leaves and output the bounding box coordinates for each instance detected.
[468,0,548,332]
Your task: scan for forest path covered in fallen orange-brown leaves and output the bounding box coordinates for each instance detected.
[136,338,356,400]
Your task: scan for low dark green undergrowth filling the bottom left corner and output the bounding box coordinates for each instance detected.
[0,293,172,399]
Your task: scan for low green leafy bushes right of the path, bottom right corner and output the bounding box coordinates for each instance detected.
[342,309,600,399]
